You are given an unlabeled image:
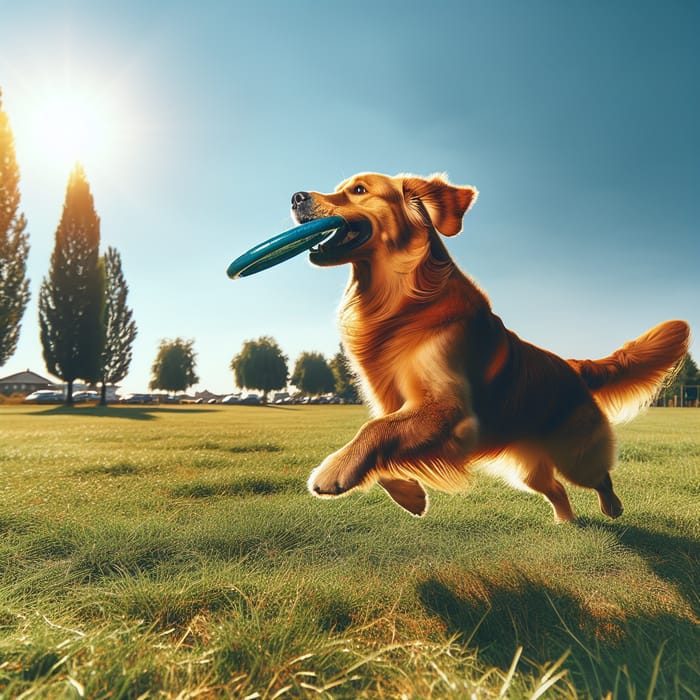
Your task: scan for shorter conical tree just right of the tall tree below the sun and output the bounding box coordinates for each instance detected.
[100,247,136,406]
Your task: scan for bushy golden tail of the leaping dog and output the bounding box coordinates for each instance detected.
[568,321,690,423]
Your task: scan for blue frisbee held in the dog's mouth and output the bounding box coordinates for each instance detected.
[226,216,347,280]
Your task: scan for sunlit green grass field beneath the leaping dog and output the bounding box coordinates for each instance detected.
[0,406,700,699]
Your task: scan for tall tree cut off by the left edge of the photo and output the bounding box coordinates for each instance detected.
[0,90,29,367]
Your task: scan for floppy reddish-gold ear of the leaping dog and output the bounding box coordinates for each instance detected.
[403,175,478,236]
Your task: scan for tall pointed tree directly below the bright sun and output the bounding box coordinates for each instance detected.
[39,163,105,404]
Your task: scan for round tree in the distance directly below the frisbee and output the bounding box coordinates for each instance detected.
[230,336,289,401]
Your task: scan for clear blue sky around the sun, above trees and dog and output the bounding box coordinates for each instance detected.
[0,0,700,392]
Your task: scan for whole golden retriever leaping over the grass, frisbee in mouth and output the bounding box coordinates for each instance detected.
[292,173,690,521]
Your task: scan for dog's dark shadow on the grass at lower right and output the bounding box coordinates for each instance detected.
[417,519,700,697]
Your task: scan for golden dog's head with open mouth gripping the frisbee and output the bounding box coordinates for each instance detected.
[292,173,477,265]
